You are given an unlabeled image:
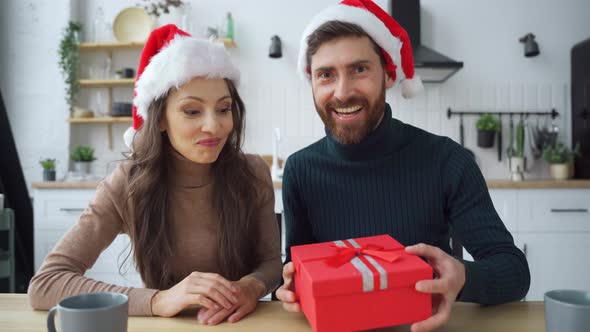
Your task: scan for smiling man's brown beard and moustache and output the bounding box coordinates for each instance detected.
[314,82,385,144]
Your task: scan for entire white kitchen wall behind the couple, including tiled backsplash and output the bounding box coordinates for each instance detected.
[0,0,590,187]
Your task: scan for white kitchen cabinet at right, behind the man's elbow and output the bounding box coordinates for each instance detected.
[490,189,590,301]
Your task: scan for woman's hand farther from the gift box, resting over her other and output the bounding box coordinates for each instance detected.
[151,272,238,317]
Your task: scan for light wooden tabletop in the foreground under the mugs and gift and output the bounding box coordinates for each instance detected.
[0,294,545,332]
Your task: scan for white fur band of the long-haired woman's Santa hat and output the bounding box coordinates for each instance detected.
[133,35,240,120]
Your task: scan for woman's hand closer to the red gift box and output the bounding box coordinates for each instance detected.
[197,277,266,325]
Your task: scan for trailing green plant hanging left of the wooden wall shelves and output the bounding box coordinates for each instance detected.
[58,21,82,115]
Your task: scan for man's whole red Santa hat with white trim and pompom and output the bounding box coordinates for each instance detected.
[298,0,424,98]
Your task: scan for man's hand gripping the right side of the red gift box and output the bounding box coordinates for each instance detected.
[406,243,465,332]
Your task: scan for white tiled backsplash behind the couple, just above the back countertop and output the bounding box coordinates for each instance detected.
[76,77,571,179]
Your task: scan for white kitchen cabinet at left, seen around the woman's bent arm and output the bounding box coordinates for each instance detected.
[33,188,142,287]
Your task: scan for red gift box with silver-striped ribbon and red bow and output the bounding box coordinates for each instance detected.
[291,235,432,332]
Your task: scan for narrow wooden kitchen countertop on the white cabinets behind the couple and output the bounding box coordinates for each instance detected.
[32,179,590,189]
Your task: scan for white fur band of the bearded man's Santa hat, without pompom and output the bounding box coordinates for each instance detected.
[297,4,406,87]
